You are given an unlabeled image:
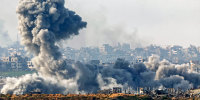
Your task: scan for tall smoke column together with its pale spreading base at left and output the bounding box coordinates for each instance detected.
[1,0,87,94]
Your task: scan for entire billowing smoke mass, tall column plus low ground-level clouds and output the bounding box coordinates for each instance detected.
[0,0,200,94]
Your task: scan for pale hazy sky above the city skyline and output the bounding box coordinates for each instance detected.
[0,0,200,48]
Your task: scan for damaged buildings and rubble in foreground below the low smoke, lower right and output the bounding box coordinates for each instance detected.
[98,87,200,98]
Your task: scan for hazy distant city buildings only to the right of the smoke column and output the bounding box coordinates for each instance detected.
[62,44,200,64]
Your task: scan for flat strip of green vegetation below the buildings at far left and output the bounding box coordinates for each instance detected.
[0,71,35,77]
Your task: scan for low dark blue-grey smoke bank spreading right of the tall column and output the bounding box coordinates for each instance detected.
[73,55,197,92]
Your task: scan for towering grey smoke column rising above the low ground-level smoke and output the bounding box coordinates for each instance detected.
[17,0,87,75]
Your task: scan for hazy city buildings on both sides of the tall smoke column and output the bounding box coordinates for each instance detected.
[0,44,200,72]
